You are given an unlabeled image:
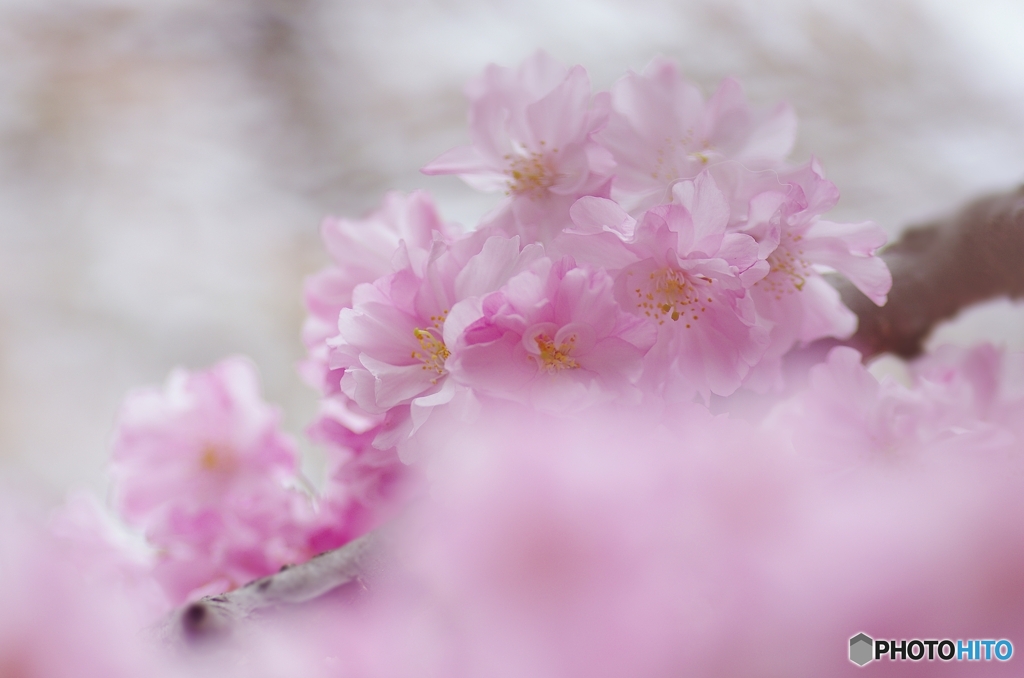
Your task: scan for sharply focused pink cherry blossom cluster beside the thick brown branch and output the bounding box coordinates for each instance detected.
[305,53,891,459]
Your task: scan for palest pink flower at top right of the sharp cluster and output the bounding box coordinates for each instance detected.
[595,59,797,211]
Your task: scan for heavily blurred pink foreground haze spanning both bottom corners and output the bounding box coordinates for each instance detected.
[12,358,1024,678]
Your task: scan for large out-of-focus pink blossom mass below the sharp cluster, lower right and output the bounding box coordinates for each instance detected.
[226,401,1024,677]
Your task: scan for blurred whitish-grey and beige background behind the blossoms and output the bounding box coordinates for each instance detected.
[0,0,1024,503]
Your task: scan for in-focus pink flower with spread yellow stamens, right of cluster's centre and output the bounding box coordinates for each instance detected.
[573,173,767,399]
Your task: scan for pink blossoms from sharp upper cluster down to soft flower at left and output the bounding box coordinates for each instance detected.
[72,53,890,604]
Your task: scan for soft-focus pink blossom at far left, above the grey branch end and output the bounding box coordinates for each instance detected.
[112,358,309,602]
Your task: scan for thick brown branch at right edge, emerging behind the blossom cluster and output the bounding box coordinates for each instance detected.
[833,186,1024,357]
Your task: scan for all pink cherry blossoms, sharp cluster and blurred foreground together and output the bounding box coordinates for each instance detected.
[8,54,1024,678]
